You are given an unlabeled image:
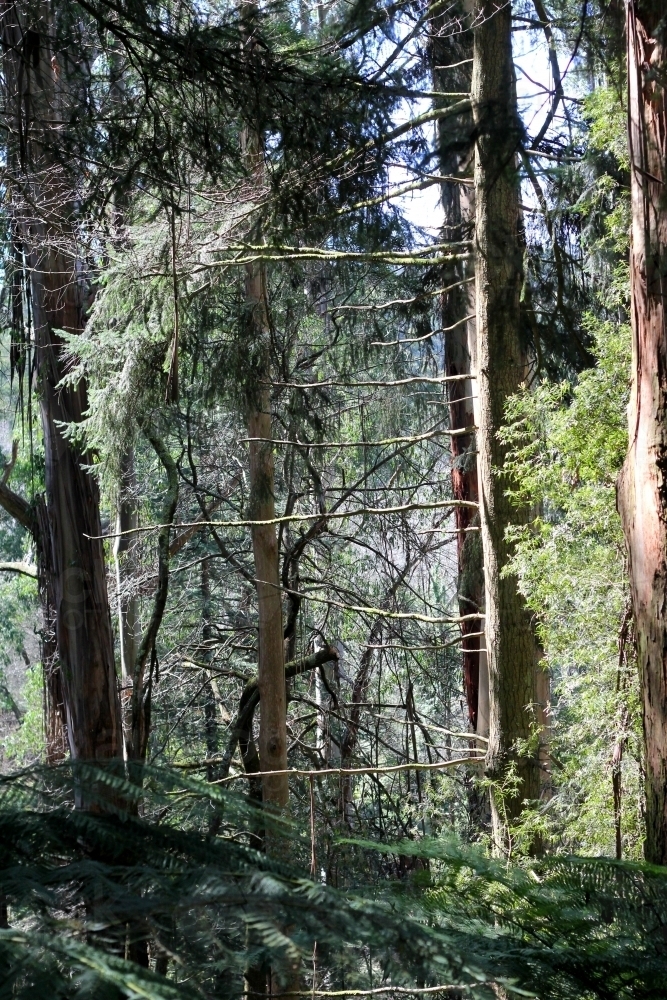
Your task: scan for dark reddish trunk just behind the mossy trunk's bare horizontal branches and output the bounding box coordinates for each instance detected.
[430,4,488,731]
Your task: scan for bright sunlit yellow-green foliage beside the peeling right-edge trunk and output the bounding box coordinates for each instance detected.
[504,318,642,857]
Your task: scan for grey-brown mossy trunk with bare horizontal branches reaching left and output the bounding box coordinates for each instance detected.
[472,0,540,850]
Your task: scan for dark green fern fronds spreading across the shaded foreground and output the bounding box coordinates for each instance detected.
[0,766,667,1000]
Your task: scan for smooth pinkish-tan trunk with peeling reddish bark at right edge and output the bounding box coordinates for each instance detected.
[618,0,667,865]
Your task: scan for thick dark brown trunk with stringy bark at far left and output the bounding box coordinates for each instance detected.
[1,3,122,760]
